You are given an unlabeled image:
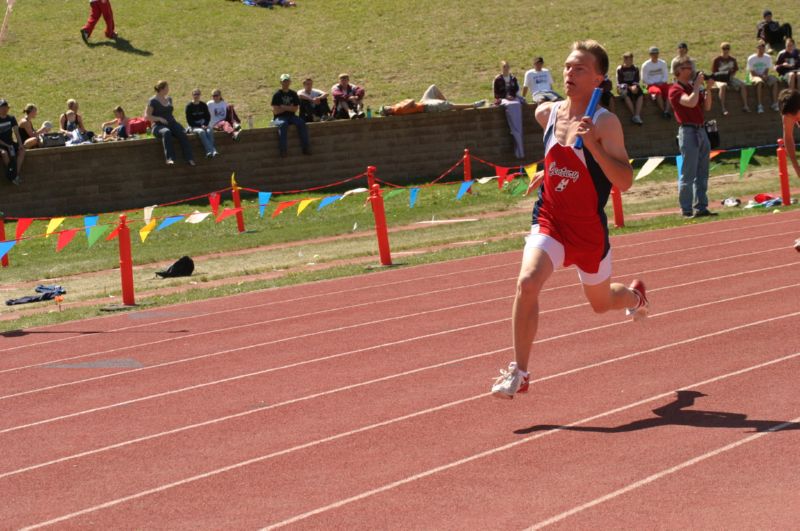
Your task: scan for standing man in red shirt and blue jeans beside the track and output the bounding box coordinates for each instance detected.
[669,57,716,218]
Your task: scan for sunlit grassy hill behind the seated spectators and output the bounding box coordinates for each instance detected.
[0,0,800,128]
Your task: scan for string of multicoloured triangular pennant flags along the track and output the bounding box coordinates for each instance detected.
[0,144,788,264]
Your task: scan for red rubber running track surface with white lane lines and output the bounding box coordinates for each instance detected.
[0,213,800,529]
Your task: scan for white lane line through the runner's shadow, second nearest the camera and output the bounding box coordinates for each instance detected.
[260,352,800,530]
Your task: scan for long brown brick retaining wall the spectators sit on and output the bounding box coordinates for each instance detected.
[0,88,780,217]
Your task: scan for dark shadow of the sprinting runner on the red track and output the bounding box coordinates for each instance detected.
[514,391,800,435]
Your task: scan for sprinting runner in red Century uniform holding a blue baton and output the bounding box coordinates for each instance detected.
[492,40,648,398]
